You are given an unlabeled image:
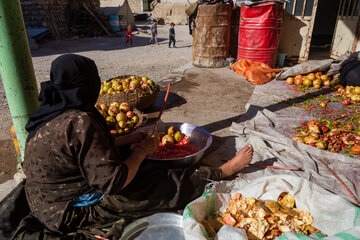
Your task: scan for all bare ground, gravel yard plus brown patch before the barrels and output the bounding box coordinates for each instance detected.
[0,26,254,193]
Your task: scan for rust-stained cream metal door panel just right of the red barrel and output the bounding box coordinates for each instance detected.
[279,0,318,61]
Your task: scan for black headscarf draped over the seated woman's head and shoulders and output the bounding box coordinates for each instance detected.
[25,54,106,141]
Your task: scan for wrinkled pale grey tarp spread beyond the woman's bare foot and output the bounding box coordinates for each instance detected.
[201,81,360,203]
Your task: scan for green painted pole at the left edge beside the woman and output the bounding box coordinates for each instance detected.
[0,0,39,160]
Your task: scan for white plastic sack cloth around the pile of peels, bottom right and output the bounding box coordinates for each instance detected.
[183,175,360,240]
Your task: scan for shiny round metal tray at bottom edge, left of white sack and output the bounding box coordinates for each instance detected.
[120,212,185,240]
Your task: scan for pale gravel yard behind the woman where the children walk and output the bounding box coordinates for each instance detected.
[0,25,192,140]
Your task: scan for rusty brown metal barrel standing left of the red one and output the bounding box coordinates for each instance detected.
[192,4,231,68]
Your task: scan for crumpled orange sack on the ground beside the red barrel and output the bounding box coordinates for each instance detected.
[230,59,281,85]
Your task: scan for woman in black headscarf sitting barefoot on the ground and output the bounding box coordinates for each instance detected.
[15,54,253,239]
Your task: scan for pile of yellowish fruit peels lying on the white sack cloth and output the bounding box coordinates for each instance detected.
[203,192,321,240]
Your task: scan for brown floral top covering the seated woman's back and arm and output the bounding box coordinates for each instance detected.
[24,110,128,232]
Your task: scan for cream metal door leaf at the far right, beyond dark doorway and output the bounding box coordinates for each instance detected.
[330,0,360,58]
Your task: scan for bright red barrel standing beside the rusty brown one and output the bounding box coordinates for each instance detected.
[237,2,284,67]
